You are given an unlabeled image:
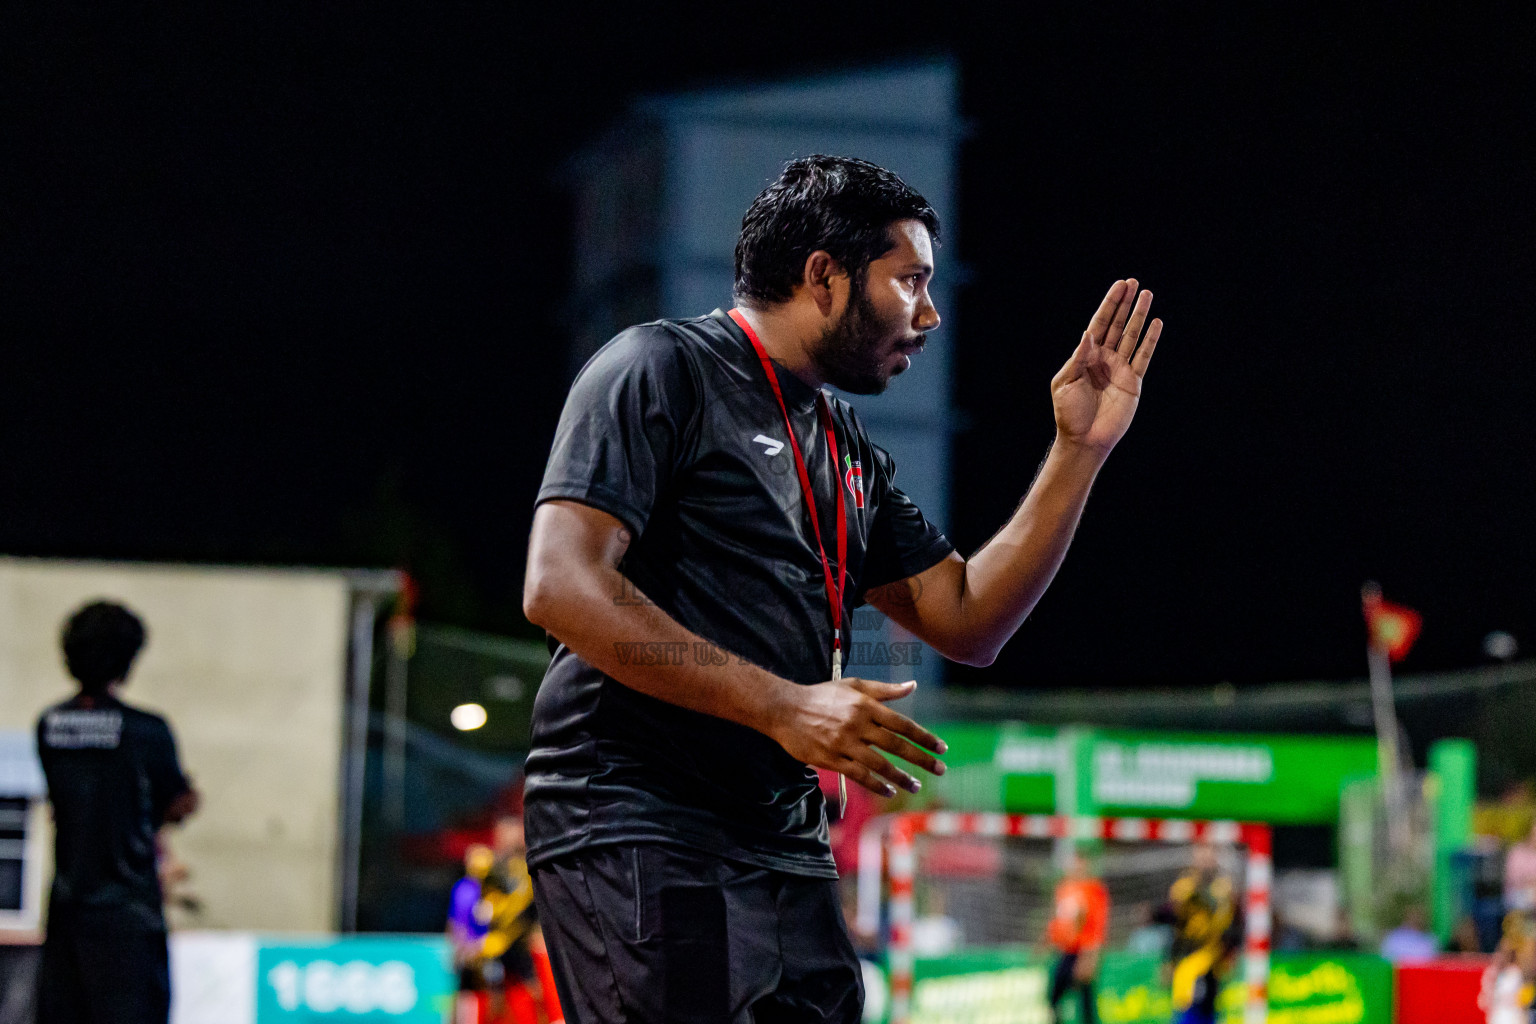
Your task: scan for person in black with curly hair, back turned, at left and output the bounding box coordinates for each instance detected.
[37,602,198,1024]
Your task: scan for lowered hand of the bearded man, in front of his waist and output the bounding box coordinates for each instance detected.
[768,677,946,797]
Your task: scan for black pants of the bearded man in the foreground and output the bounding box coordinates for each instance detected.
[533,844,863,1024]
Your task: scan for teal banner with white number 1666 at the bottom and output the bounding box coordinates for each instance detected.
[257,935,455,1024]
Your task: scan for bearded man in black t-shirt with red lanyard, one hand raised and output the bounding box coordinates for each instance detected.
[524,157,1161,1024]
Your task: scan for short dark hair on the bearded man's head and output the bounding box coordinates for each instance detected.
[736,155,938,304]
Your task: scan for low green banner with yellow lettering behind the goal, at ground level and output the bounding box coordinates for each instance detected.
[878,949,1392,1024]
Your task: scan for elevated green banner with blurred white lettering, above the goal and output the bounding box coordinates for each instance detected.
[928,723,1376,824]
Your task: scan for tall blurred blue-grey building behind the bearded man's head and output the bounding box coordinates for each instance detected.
[567,60,963,694]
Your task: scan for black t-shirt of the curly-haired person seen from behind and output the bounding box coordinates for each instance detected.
[37,695,189,929]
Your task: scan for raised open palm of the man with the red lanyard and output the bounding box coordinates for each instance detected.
[1051,278,1163,451]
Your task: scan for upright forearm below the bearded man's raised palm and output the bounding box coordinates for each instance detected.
[960,439,1107,656]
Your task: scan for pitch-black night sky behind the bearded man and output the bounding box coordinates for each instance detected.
[0,3,1536,686]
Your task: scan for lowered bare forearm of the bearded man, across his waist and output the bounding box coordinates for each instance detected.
[528,567,791,735]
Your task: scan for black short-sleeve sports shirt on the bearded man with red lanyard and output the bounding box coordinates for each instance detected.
[525,310,954,877]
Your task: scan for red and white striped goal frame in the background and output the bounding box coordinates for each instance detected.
[860,811,1273,1024]
